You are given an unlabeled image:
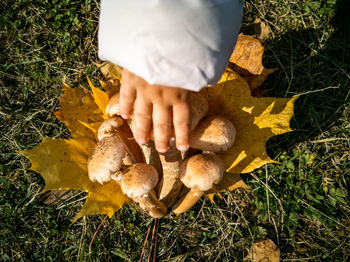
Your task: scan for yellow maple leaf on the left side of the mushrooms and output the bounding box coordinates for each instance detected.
[18,82,129,221]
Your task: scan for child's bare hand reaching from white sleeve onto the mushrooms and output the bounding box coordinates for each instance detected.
[120,69,190,153]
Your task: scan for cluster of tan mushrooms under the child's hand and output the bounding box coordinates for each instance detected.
[88,92,236,218]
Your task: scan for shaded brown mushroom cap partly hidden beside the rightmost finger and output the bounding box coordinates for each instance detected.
[190,92,209,130]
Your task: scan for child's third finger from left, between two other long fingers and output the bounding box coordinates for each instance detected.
[152,104,172,153]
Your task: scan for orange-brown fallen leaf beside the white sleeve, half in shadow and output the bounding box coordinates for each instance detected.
[229,34,276,92]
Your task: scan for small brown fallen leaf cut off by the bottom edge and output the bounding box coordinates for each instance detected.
[244,239,280,262]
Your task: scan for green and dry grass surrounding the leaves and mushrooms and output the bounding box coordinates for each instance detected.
[0,0,350,261]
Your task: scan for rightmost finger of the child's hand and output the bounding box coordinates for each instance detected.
[173,103,191,151]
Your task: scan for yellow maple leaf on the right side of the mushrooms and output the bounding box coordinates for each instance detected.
[201,71,297,174]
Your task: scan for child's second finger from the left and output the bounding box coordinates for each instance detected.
[133,96,152,145]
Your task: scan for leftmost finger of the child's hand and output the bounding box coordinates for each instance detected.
[119,83,136,119]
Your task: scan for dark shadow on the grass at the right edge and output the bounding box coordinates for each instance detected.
[263,1,350,157]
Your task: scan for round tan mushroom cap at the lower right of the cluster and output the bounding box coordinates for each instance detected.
[180,153,224,192]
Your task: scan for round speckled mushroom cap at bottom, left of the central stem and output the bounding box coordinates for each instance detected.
[120,163,158,198]
